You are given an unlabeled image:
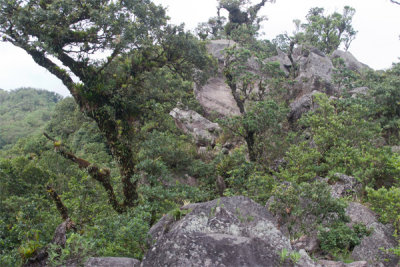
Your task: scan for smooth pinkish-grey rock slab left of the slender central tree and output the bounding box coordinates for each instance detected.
[194,75,240,116]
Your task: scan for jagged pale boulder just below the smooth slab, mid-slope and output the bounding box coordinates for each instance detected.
[169,108,221,146]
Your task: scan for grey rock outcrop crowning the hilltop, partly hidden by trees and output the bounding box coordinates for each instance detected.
[194,40,369,121]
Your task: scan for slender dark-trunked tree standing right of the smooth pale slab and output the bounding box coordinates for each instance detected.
[224,46,284,162]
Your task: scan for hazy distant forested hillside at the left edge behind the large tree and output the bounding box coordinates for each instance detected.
[0,88,62,148]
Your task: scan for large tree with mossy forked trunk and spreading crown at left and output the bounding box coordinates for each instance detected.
[0,0,209,212]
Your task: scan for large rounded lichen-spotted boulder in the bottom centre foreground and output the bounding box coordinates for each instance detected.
[141,197,316,267]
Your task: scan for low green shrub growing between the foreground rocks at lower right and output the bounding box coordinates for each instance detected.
[318,223,371,257]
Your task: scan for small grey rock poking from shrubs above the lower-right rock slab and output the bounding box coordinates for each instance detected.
[331,173,362,198]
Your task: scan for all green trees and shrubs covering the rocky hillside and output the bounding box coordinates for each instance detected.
[0,0,400,266]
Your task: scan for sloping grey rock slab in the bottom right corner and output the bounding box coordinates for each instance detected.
[346,202,399,267]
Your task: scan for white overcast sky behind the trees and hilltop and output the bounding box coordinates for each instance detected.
[0,0,400,96]
